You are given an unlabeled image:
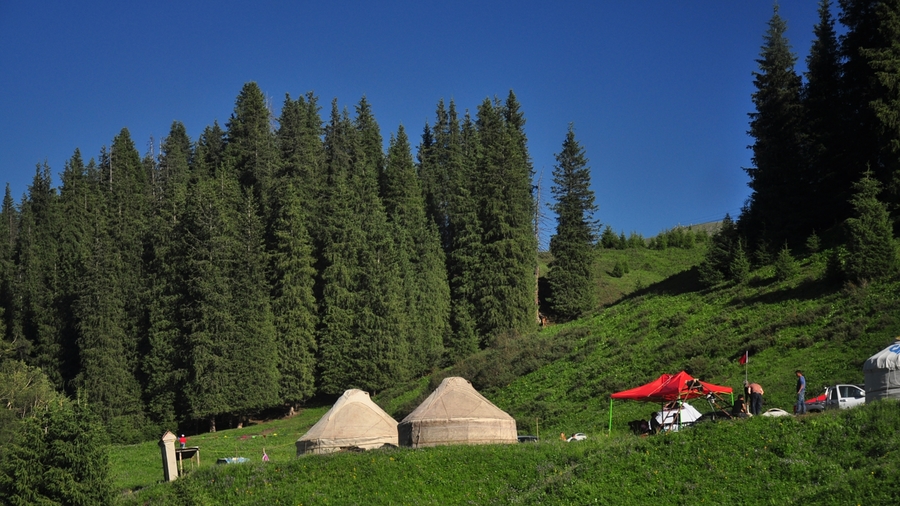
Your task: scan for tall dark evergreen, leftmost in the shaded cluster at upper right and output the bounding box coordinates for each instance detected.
[739,5,813,247]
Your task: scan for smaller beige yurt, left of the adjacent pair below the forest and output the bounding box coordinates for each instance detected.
[296,388,397,455]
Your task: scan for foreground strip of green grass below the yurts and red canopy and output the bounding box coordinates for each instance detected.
[121,402,900,505]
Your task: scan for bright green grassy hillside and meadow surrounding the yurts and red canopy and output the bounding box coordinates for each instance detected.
[111,243,900,504]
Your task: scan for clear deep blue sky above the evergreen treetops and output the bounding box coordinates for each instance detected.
[0,0,817,243]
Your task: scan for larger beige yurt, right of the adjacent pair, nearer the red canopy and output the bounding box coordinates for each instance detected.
[397,378,518,448]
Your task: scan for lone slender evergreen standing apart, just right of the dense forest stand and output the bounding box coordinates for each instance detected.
[547,124,597,319]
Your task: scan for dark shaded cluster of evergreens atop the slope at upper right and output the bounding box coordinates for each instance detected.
[701,0,900,284]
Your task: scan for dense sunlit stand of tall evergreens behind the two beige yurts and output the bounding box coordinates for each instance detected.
[0,83,608,441]
